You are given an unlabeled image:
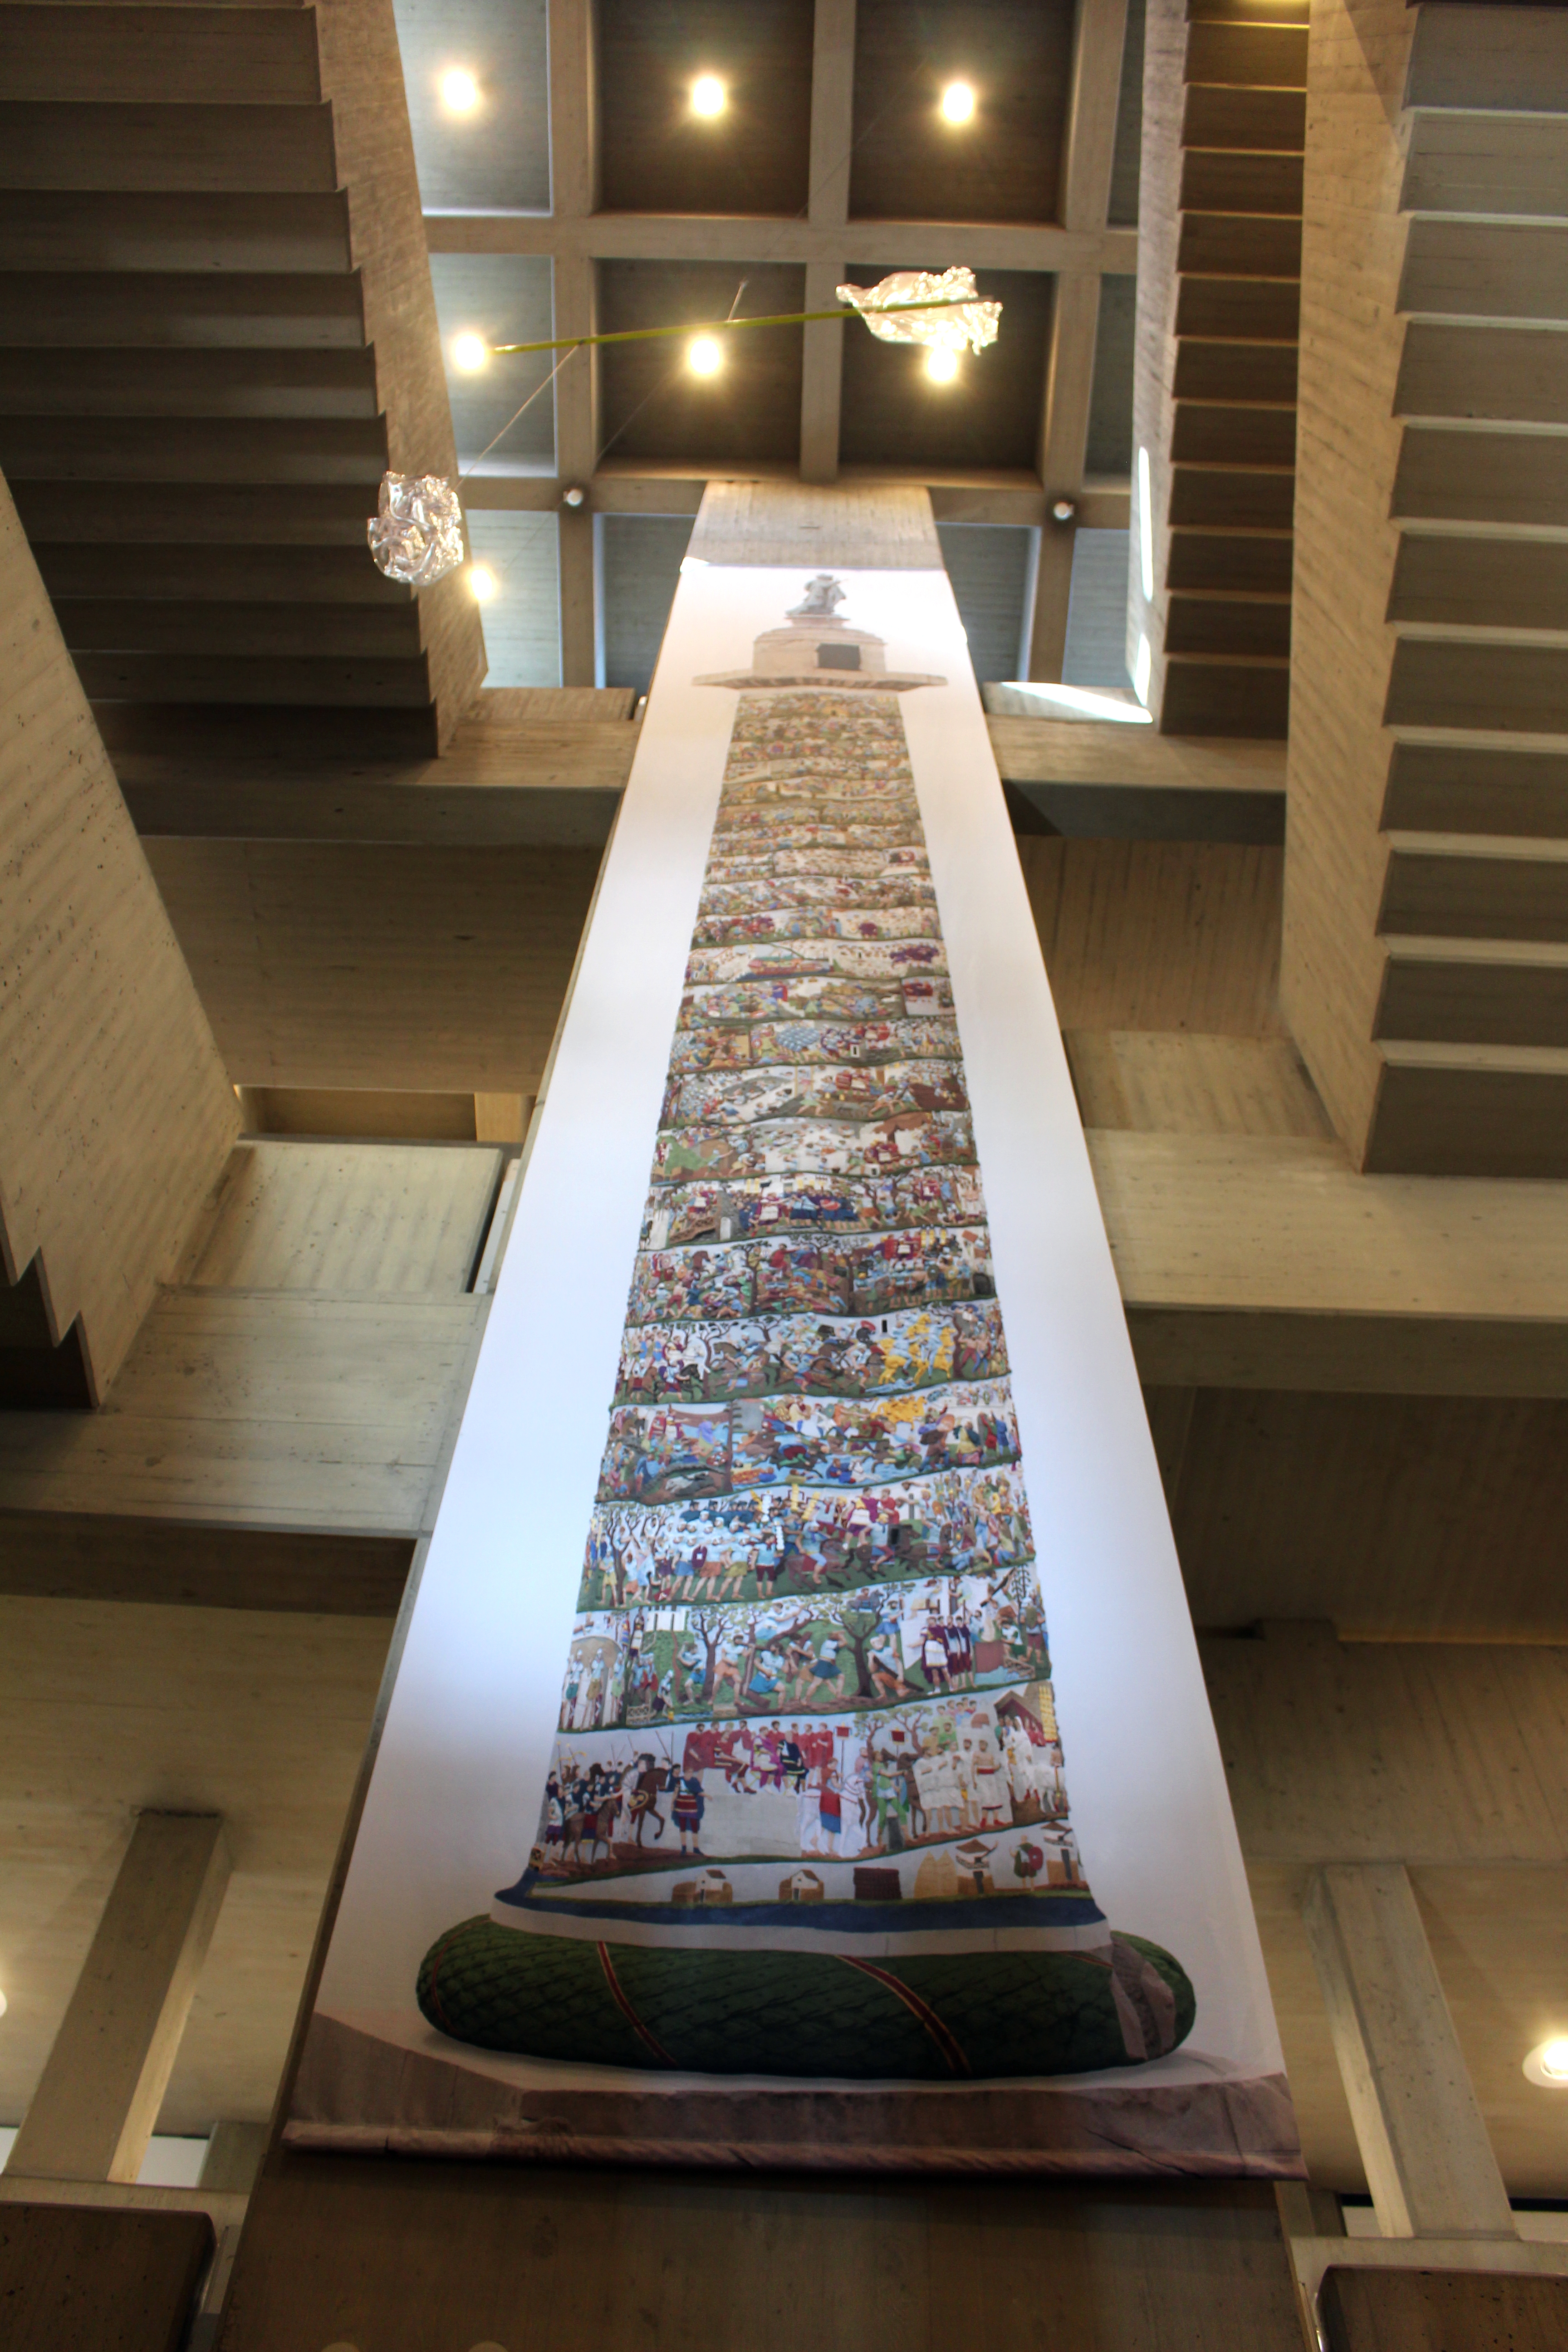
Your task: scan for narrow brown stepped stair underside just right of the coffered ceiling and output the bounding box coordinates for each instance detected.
[1159,0,1307,736]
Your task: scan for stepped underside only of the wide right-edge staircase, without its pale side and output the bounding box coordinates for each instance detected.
[1368,10,1568,1176]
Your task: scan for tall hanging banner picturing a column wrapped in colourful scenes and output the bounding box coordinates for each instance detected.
[289,541,1300,2176]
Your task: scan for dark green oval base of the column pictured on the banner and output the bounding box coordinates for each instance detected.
[418,1915,1196,2082]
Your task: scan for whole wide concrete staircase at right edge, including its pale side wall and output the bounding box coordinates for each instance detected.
[1284,0,1568,1176]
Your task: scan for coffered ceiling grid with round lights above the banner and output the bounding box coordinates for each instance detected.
[397,0,1142,682]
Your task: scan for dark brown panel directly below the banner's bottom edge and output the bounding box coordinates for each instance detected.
[221,2157,1300,2352]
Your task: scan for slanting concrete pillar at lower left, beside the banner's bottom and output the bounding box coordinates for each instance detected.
[7,1813,228,2180]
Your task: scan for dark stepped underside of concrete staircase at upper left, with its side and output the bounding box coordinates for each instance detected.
[0,0,482,755]
